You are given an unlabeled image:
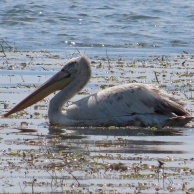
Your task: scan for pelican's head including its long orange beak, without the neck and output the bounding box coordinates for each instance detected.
[4,56,91,117]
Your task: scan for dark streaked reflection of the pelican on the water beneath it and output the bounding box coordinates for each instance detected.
[49,126,186,154]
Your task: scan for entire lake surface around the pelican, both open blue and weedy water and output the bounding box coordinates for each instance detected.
[0,0,194,194]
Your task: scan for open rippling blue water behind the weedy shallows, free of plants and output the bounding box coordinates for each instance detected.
[0,0,194,58]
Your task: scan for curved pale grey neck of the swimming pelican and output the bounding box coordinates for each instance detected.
[48,71,91,124]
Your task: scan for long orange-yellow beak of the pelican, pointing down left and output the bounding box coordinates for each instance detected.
[4,68,73,117]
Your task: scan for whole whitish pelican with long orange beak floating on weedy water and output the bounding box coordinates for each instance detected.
[4,56,194,127]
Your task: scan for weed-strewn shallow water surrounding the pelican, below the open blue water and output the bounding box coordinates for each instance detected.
[0,50,194,193]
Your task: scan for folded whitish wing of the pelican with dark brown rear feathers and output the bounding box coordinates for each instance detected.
[67,83,188,119]
